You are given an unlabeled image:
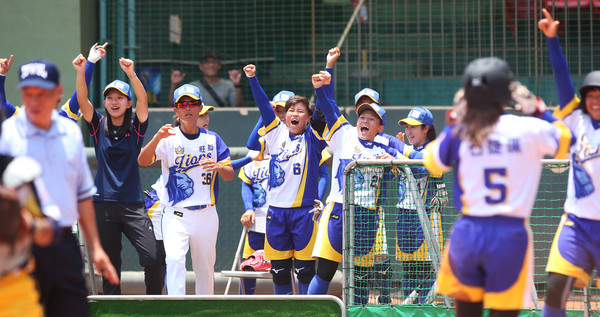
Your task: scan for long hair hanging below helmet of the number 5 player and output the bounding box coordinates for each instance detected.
[457,105,503,146]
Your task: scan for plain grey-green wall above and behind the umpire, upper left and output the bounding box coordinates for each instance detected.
[0,0,98,105]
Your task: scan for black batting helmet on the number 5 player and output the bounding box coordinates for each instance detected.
[463,57,513,107]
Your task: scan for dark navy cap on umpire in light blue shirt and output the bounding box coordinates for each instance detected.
[17,59,60,89]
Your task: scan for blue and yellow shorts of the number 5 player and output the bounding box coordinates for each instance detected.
[438,216,533,310]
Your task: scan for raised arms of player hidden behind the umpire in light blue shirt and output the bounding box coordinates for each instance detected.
[0,43,108,121]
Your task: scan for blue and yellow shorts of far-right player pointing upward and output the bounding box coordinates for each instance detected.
[546,214,600,287]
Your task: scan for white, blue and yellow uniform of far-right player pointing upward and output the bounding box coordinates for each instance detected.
[546,37,600,287]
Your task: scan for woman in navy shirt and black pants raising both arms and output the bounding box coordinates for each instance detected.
[73,54,162,295]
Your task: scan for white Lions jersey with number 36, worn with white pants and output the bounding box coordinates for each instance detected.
[155,127,231,208]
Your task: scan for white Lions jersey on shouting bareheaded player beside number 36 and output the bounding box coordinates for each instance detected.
[262,118,327,208]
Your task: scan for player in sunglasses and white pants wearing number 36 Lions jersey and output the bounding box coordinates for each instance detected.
[138,84,233,295]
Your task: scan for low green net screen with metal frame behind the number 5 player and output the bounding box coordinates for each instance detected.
[342,160,600,316]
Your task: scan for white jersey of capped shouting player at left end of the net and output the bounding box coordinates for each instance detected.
[327,117,401,209]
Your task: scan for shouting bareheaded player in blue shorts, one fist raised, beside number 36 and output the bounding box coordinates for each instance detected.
[244,65,326,294]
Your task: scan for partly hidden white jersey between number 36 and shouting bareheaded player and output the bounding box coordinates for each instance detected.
[238,151,271,217]
